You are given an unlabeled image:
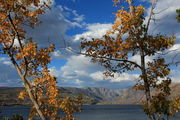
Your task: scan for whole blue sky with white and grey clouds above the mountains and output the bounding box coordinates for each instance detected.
[0,0,180,89]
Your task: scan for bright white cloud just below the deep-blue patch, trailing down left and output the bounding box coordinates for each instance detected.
[53,23,112,58]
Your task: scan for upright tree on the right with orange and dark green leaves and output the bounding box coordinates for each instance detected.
[81,0,175,120]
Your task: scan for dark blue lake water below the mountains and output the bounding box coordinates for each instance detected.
[0,105,180,120]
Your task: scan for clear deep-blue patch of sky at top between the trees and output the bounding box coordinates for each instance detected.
[55,0,150,35]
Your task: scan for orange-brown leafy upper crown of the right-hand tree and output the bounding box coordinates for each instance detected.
[81,0,175,75]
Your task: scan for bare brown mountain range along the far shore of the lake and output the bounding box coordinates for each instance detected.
[0,83,180,105]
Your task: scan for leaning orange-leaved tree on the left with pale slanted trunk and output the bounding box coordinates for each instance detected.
[0,0,80,120]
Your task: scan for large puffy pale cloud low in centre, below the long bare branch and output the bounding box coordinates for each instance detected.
[50,55,102,86]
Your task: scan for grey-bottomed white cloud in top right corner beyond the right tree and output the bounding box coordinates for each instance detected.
[147,0,180,38]
